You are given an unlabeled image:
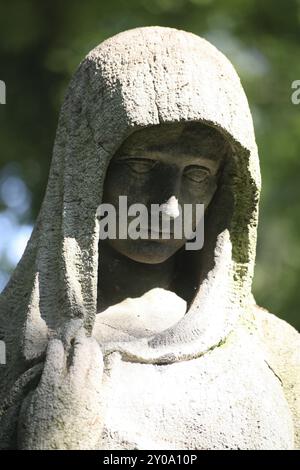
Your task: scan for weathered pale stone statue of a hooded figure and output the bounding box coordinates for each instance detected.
[0,27,300,449]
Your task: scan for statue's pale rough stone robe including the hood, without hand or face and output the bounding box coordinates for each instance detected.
[0,27,300,449]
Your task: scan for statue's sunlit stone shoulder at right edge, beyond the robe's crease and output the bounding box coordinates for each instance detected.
[253,306,300,449]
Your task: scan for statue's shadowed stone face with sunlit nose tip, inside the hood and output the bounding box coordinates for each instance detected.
[102,123,228,264]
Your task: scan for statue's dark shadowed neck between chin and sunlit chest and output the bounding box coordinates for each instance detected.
[98,240,175,313]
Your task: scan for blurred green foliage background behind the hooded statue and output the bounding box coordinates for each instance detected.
[0,0,300,330]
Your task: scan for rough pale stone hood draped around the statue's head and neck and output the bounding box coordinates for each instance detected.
[0,27,260,390]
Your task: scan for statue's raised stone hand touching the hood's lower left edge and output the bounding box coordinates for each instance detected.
[18,329,103,449]
